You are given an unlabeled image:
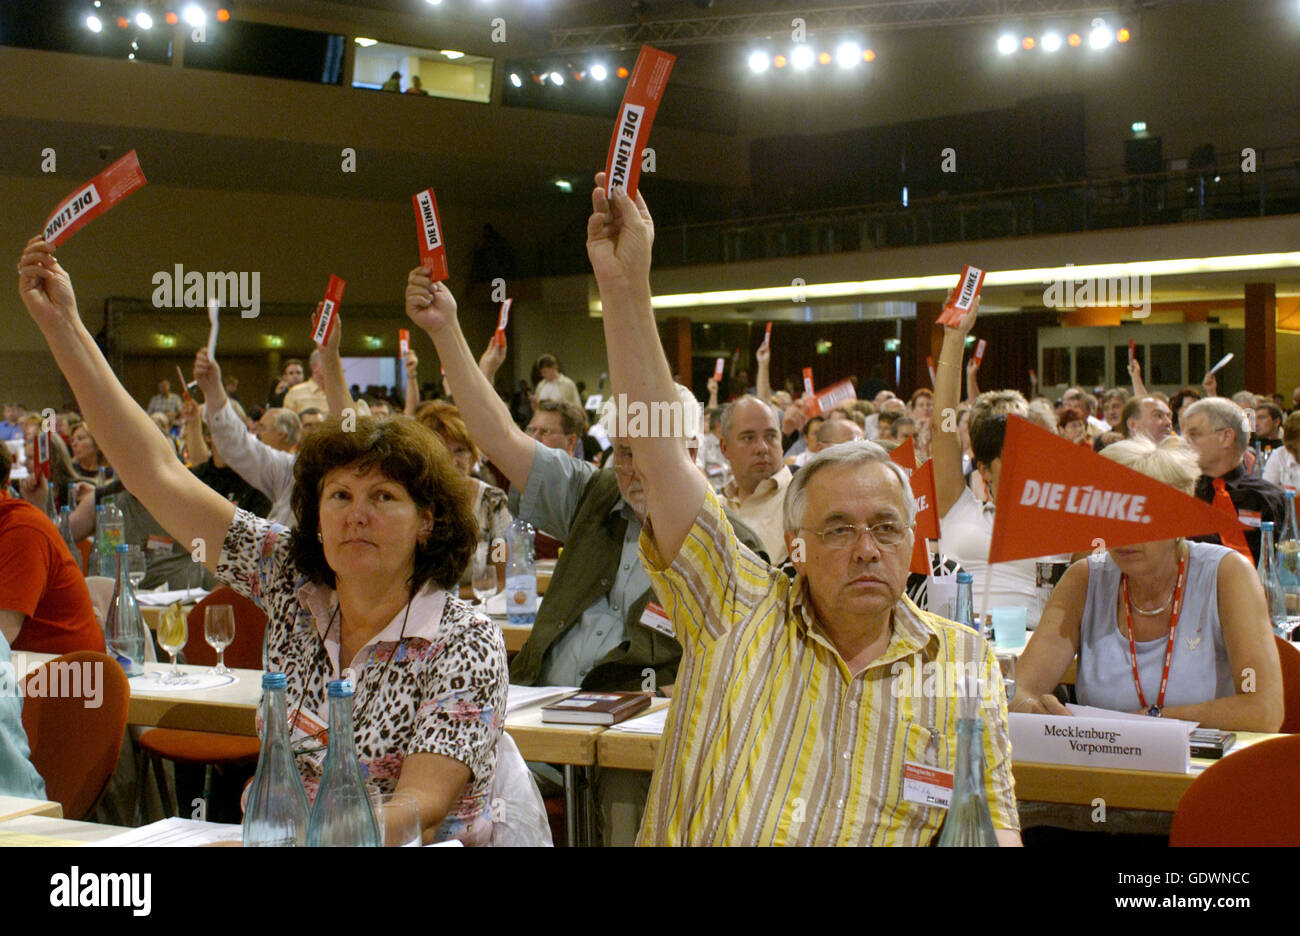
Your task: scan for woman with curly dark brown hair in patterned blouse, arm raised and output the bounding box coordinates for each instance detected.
[18,238,507,844]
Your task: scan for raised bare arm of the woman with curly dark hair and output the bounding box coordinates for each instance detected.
[18,237,235,571]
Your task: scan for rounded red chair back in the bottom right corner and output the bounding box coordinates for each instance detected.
[1169,735,1300,846]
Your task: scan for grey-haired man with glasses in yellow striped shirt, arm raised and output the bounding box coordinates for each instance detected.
[588,173,1021,845]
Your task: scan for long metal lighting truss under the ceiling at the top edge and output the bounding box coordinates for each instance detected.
[550,0,1152,53]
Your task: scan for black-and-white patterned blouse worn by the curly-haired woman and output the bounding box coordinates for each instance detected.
[217,510,508,845]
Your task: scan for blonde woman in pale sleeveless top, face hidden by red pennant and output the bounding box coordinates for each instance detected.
[1009,437,1283,732]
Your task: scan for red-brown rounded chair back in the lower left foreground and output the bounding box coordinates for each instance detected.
[22,650,131,819]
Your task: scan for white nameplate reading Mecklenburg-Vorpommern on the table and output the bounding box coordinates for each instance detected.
[1008,712,1192,774]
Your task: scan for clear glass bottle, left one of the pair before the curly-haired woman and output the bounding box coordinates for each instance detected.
[243,673,311,848]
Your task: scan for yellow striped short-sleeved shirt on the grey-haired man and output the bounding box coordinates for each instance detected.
[638,491,1019,845]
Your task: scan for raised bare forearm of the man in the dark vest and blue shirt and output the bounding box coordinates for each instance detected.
[406,267,537,490]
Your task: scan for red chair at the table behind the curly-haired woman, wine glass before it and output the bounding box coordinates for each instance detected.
[137,585,267,815]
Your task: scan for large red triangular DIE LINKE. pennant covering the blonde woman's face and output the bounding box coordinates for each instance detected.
[988,416,1242,563]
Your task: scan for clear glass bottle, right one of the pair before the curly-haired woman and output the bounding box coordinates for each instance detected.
[307,680,381,846]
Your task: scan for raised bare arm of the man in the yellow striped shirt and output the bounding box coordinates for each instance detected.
[586,173,709,563]
